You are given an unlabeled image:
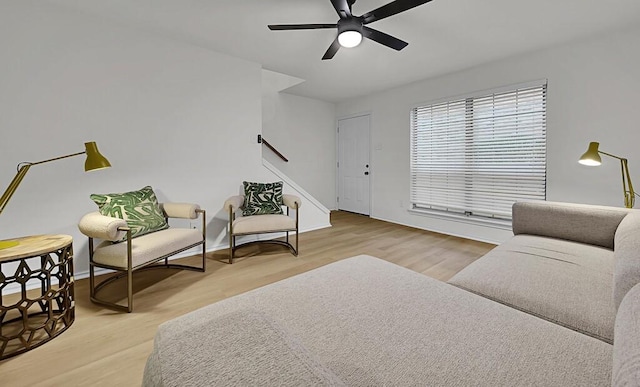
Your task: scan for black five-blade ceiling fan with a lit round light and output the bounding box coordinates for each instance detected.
[268,0,431,60]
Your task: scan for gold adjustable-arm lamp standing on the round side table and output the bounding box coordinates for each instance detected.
[0,141,111,250]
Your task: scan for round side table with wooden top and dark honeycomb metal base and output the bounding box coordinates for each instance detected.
[0,235,75,360]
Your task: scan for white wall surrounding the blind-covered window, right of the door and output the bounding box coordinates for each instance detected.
[337,24,640,242]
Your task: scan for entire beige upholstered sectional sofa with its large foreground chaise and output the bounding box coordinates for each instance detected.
[143,202,640,386]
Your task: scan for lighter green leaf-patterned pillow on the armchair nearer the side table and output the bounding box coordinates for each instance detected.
[90,186,169,240]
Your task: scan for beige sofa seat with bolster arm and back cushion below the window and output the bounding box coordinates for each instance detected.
[449,201,640,343]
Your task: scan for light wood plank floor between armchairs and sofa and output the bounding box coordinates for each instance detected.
[0,211,494,387]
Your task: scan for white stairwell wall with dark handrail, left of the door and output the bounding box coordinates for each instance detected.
[262,70,336,208]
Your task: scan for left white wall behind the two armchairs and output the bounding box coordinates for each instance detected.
[0,0,328,273]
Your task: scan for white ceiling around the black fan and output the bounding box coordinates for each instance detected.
[48,0,640,101]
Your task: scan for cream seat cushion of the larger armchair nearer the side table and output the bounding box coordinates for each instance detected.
[93,228,202,269]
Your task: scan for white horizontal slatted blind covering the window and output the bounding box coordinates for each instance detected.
[411,82,547,219]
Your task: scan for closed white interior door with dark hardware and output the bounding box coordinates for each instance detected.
[338,115,371,215]
